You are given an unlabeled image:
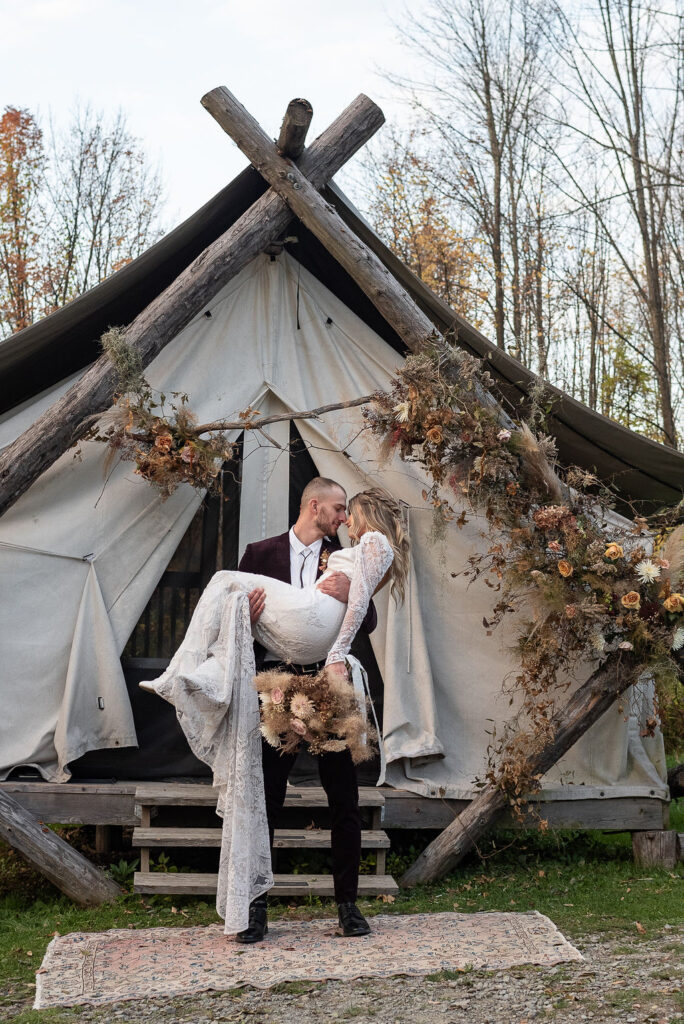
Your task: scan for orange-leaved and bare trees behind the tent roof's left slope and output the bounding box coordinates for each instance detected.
[0,108,162,337]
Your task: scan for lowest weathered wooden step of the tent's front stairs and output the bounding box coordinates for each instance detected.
[133,871,399,896]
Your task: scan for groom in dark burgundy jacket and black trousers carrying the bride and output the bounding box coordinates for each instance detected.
[237,476,378,943]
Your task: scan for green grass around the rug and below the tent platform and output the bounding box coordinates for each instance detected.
[0,801,684,1024]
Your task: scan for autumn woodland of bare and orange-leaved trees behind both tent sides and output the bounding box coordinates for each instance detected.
[0,0,684,446]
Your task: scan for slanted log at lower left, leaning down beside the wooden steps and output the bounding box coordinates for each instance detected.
[0,791,121,906]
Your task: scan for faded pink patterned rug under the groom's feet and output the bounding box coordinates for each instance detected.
[35,911,583,1010]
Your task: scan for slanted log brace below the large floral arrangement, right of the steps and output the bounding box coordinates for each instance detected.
[399,658,642,887]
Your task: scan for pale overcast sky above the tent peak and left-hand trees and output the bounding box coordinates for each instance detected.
[0,0,427,226]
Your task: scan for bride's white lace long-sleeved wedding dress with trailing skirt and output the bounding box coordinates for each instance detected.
[141,531,393,935]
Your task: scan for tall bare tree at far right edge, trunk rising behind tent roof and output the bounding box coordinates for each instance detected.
[554,0,684,446]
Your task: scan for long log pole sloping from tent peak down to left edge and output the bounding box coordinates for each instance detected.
[0,94,385,515]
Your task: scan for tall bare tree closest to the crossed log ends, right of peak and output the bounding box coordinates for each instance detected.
[385,0,548,349]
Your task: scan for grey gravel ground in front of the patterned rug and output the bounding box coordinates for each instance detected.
[5,926,684,1024]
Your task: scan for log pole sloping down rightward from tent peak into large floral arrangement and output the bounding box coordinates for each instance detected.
[202,86,514,427]
